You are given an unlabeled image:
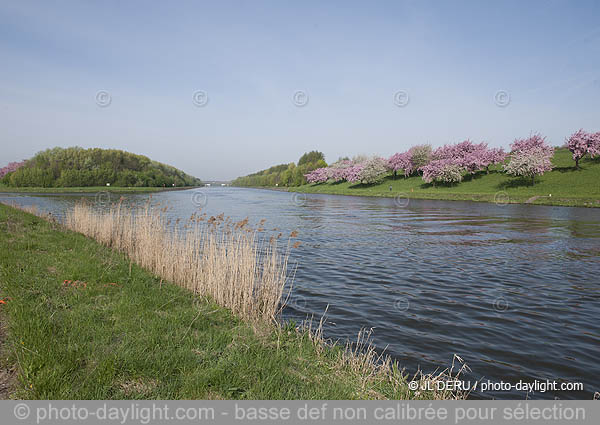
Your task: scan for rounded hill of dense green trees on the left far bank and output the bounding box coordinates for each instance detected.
[0,147,202,187]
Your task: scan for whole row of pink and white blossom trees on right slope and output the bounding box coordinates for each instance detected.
[305,130,600,184]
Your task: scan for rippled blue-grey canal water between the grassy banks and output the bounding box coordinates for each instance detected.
[0,188,600,399]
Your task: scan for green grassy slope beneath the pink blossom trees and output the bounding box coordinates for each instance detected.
[288,149,600,207]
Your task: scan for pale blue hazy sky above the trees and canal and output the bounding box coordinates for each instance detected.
[0,0,600,179]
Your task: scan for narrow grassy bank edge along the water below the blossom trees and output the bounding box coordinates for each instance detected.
[239,185,600,208]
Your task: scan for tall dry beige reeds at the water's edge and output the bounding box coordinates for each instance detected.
[65,202,288,320]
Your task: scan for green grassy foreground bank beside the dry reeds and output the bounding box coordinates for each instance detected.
[0,204,428,399]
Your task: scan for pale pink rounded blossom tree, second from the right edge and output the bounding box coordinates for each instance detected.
[504,134,554,184]
